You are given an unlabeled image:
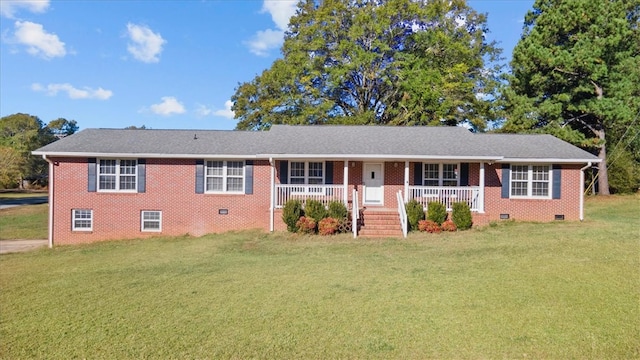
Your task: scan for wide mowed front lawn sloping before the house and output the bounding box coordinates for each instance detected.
[0,196,640,359]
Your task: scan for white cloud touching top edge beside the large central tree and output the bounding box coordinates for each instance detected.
[246,0,297,56]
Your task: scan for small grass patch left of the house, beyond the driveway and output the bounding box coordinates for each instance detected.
[0,204,49,240]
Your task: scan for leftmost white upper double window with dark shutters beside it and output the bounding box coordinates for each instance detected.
[98,159,137,192]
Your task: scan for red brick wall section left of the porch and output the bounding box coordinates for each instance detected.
[52,158,270,244]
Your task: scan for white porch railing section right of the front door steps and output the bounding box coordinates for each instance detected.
[409,185,480,211]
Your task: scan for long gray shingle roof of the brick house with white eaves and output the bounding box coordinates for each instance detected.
[34,125,598,162]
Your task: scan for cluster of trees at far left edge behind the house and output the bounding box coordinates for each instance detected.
[0,113,78,188]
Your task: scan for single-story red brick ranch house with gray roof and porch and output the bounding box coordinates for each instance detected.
[33,125,599,246]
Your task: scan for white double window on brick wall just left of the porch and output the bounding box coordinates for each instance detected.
[205,160,244,193]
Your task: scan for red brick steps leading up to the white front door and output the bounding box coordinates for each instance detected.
[358,207,402,237]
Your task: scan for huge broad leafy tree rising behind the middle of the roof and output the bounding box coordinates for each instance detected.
[232,0,499,130]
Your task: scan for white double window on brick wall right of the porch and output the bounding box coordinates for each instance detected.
[510,165,551,198]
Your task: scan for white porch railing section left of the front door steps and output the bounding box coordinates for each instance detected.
[274,184,344,209]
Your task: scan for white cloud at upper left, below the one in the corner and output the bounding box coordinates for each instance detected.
[10,21,67,59]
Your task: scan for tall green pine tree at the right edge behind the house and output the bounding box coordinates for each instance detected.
[502,0,640,194]
